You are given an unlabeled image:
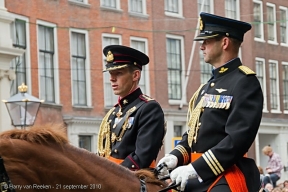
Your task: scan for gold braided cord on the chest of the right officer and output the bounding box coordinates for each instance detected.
[187,84,204,147]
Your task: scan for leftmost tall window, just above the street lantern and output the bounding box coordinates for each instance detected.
[10,19,27,95]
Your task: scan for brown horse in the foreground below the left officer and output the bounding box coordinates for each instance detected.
[0,126,165,192]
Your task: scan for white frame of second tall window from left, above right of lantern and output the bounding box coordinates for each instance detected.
[36,20,60,104]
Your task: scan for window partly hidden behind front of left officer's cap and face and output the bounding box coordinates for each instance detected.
[102,34,122,107]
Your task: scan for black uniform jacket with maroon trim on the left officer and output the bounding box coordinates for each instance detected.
[98,88,165,170]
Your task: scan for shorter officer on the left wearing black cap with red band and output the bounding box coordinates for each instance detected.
[97,45,165,170]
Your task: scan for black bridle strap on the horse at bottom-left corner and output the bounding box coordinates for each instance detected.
[0,157,15,192]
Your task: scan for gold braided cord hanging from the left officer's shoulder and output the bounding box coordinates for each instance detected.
[97,107,115,158]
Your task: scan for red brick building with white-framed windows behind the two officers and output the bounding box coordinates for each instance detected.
[4,0,288,183]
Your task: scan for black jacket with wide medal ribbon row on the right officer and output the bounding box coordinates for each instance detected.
[171,58,263,192]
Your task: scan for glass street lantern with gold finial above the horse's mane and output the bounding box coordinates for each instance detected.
[3,83,44,129]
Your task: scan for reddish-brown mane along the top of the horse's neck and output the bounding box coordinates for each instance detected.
[0,125,68,145]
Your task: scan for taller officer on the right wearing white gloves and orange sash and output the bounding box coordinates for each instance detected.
[158,13,263,192]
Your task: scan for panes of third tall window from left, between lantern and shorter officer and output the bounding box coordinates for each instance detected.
[71,32,87,106]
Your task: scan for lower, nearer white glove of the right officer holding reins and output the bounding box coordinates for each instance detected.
[170,163,198,191]
